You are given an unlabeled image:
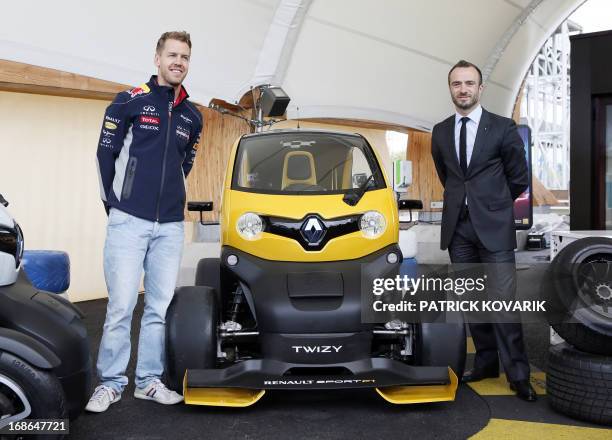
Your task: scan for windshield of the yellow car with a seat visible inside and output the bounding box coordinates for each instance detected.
[232,132,385,194]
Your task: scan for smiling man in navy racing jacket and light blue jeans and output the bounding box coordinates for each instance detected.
[86,32,202,412]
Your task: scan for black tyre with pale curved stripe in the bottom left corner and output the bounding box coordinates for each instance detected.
[0,353,68,439]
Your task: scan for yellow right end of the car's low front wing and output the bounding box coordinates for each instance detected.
[376,368,459,404]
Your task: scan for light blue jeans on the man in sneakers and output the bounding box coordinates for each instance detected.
[97,208,184,393]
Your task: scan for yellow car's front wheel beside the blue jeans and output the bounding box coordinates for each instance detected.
[165,286,219,393]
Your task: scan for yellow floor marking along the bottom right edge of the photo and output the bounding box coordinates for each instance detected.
[470,419,611,440]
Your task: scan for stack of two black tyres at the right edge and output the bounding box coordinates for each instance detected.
[543,237,612,425]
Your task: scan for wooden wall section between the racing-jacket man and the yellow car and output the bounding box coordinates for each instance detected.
[185,107,250,221]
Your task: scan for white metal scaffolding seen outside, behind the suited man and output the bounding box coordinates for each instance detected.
[521,20,582,190]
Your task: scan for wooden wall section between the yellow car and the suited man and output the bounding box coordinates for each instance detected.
[406,130,444,211]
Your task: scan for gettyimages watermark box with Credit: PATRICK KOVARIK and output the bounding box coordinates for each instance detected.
[362,263,549,323]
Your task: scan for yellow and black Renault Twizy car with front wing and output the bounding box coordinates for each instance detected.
[166,130,465,406]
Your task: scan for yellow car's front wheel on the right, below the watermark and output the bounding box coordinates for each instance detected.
[415,315,466,380]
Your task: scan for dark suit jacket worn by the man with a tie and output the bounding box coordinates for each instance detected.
[431,109,529,252]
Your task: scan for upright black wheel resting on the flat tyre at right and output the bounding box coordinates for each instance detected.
[543,237,612,355]
